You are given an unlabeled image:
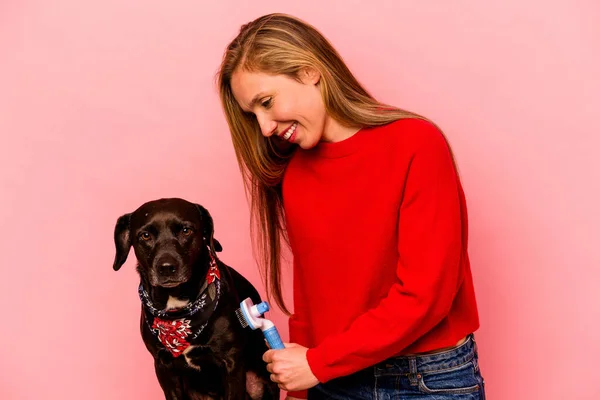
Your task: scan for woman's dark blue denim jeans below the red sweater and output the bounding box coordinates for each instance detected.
[308,334,485,400]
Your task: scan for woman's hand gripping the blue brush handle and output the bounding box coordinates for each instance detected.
[263,343,319,392]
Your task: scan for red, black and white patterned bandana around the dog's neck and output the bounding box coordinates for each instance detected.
[138,249,221,357]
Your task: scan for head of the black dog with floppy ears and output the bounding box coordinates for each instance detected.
[113,198,222,288]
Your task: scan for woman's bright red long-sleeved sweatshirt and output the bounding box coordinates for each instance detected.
[283,120,479,397]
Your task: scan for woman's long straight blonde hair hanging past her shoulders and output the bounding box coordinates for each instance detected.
[217,14,436,315]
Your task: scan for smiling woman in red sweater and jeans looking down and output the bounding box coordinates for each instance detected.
[218,14,484,399]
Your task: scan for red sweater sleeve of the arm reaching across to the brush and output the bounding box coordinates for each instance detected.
[307,129,463,382]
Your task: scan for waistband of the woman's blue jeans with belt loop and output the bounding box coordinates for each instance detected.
[375,333,477,376]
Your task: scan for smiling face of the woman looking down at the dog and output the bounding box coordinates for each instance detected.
[231,69,334,149]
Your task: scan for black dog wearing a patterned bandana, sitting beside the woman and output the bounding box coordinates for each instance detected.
[113,198,279,400]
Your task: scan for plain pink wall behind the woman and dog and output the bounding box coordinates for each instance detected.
[0,0,600,400]
